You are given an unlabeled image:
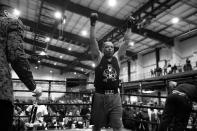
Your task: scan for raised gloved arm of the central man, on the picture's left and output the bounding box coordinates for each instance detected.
[90,13,101,61]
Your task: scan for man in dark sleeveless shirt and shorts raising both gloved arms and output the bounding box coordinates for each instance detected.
[90,13,132,131]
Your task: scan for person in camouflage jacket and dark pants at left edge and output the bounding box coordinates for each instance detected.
[0,4,41,131]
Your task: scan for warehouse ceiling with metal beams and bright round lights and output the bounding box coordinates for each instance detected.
[0,0,197,76]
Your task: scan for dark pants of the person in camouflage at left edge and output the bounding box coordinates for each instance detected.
[0,100,13,131]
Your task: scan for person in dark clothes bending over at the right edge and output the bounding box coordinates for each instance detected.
[159,81,197,131]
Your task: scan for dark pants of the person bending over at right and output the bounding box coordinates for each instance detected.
[158,94,192,131]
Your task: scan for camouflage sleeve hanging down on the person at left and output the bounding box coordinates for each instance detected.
[7,19,36,91]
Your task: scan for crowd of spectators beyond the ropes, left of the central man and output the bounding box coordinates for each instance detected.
[13,99,91,131]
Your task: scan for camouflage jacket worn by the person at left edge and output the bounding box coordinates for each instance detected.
[0,17,36,101]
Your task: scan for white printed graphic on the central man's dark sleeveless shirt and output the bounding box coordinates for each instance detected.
[103,64,117,82]
